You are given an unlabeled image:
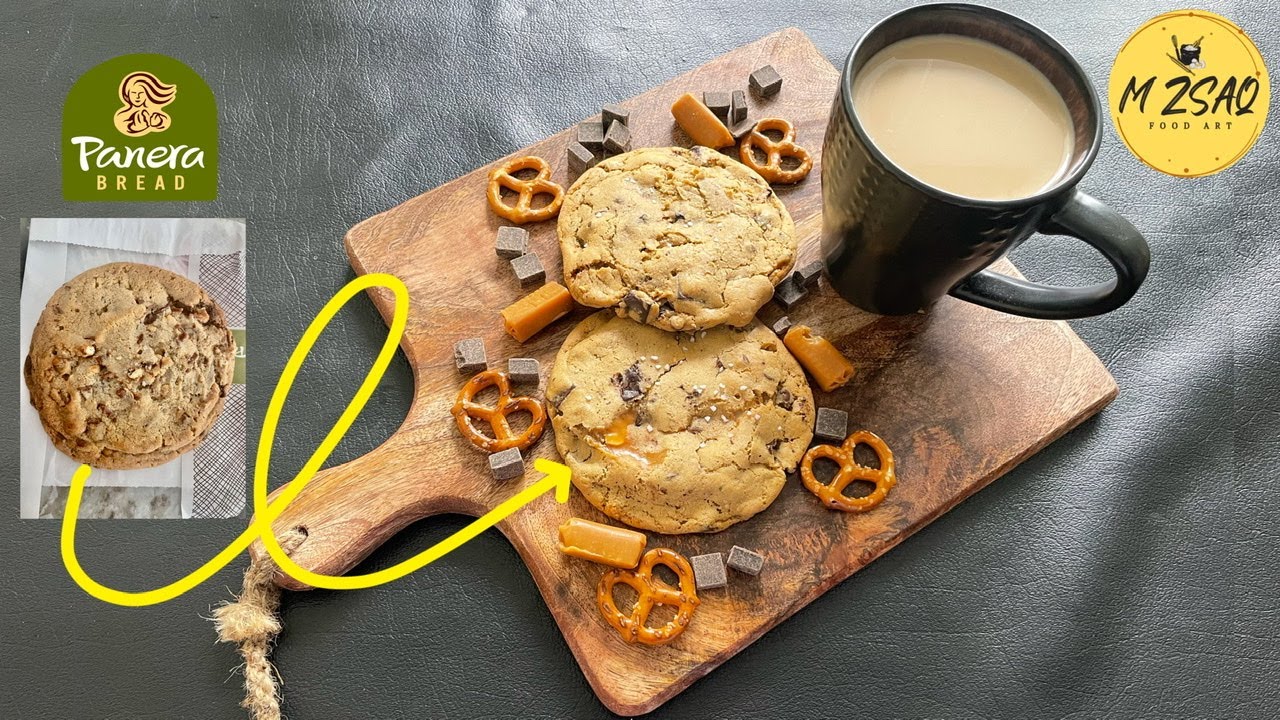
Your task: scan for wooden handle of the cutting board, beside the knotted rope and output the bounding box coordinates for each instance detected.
[250,436,484,591]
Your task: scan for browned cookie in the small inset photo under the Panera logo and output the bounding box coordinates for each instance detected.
[24,263,236,469]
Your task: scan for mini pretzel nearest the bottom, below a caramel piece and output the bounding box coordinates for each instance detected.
[595,547,699,644]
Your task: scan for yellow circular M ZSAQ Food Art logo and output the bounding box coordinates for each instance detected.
[1107,10,1271,178]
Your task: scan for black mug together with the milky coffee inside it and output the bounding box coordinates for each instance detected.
[822,3,1151,319]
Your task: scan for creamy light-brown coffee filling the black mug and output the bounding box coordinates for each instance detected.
[854,35,1074,200]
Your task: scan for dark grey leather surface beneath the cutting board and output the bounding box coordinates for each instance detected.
[0,0,1280,720]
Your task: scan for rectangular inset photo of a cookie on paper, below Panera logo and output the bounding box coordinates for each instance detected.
[20,219,246,518]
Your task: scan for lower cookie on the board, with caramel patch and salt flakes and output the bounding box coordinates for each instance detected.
[547,311,814,533]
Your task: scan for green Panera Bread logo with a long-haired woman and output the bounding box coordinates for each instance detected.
[61,54,218,201]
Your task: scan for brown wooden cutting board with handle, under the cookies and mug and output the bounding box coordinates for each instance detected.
[254,29,1116,715]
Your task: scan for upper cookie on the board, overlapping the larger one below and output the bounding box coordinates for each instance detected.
[558,146,796,331]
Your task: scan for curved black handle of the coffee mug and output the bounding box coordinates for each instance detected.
[951,188,1151,320]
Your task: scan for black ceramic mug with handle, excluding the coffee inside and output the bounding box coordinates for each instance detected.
[822,4,1151,319]
